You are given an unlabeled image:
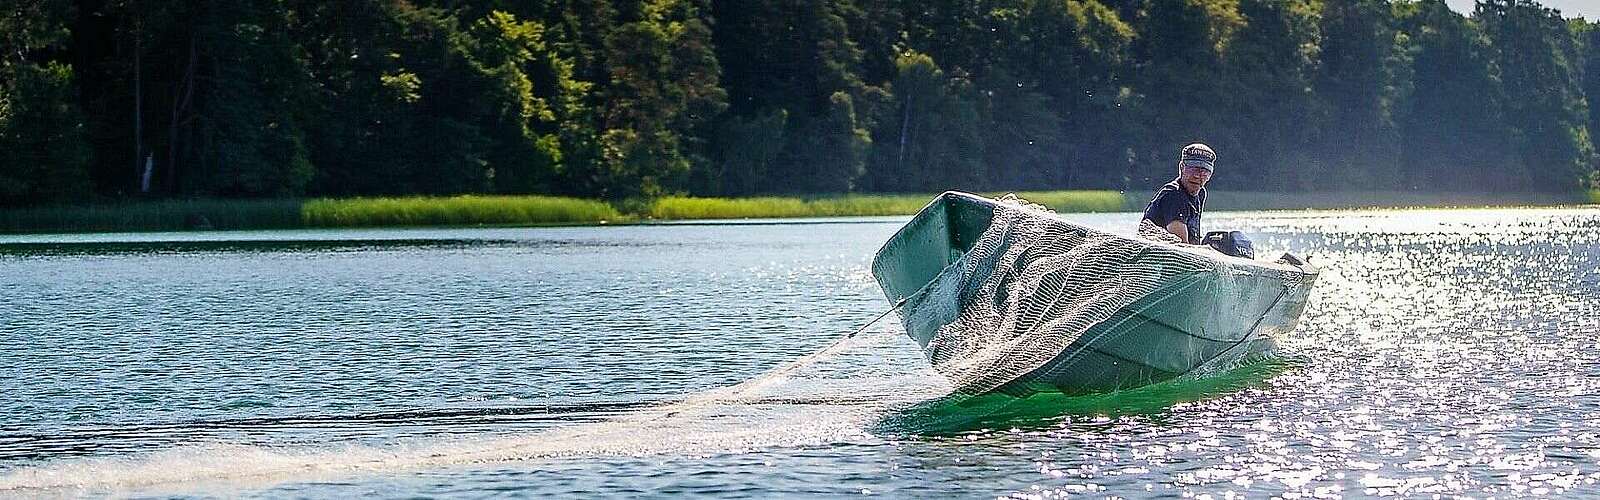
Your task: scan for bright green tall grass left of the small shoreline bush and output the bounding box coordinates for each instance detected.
[301,196,622,228]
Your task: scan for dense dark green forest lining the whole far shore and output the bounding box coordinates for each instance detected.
[0,0,1600,205]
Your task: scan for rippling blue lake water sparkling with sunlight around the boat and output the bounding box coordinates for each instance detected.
[0,208,1600,498]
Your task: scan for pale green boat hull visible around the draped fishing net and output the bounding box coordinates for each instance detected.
[872,192,1317,396]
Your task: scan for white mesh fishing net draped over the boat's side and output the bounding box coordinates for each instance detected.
[901,199,1232,394]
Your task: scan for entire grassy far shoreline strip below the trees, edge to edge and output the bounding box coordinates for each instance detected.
[0,189,1600,234]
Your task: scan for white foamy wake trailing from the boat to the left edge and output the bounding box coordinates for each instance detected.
[0,323,950,495]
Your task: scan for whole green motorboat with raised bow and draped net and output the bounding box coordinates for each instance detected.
[872,191,1318,396]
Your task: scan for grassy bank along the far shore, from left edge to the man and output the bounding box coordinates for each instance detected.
[0,191,1126,232]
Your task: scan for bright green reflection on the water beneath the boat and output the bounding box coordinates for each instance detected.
[874,357,1301,436]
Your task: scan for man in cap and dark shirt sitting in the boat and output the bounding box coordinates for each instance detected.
[1141,143,1216,245]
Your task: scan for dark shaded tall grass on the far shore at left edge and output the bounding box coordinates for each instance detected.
[0,200,301,232]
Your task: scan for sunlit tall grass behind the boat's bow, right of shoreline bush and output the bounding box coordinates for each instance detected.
[643,191,1128,220]
